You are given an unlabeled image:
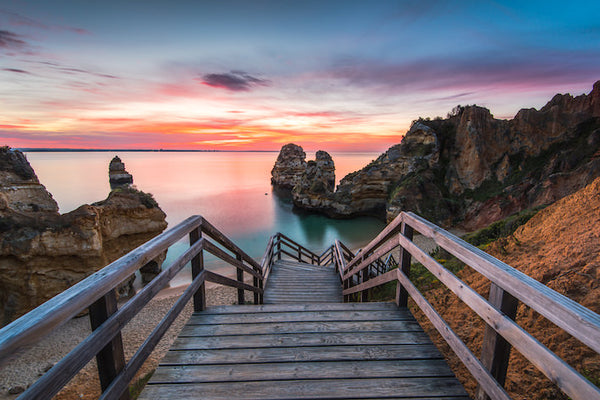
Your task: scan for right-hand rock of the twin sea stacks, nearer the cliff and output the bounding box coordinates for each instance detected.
[292,150,335,210]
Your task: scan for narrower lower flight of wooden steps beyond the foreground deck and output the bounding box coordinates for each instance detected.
[264,260,342,304]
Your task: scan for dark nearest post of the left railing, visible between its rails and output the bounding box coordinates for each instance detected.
[89,290,129,400]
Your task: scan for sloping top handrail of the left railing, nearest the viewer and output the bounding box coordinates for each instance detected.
[0,216,202,363]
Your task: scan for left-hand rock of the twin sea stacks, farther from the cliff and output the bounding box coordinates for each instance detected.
[271,143,306,189]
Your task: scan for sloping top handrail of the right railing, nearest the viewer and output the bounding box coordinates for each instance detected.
[405,213,600,353]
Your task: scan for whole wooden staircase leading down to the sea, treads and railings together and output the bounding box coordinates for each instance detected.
[0,212,600,400]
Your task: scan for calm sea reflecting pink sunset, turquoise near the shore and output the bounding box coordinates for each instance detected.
[26,152,384,286]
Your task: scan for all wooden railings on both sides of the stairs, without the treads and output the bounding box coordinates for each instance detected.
[0,212,600,400]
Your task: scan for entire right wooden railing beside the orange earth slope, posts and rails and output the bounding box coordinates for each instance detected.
[334,212,600,400]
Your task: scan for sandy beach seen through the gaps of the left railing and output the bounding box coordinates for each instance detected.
[0,286,252,400]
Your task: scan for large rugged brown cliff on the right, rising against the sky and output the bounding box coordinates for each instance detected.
[296,81,600,230]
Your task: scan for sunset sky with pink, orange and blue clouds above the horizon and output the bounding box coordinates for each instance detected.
[0,0,600,151]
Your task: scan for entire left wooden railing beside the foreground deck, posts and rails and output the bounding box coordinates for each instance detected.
[0,216,264,399]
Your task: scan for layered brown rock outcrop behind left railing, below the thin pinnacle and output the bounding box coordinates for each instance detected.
[0,147,167,325]
